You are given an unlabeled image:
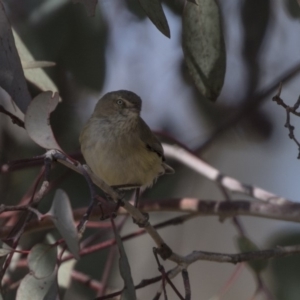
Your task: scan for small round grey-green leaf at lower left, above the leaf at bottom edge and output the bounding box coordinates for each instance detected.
[28,244,57,279]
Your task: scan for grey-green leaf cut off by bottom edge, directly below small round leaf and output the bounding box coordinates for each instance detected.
[16,271,56,300]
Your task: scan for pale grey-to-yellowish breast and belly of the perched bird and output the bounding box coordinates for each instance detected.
[80,116,164,186]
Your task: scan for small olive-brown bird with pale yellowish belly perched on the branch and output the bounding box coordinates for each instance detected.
[79,90,174,206]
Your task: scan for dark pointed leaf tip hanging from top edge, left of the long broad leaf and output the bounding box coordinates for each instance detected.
[139,0,170,38]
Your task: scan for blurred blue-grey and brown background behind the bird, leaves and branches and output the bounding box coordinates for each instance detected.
[0,0,300,300]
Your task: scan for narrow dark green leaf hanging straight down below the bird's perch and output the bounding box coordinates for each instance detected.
[113,223,136,300]
